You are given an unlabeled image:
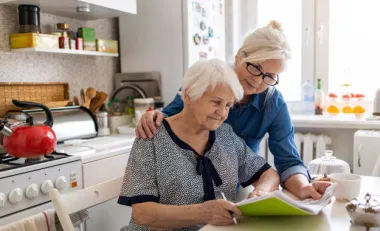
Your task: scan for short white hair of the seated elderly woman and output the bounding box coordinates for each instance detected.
[181,59,244,102]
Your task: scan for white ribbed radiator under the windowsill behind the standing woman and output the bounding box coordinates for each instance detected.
[258,133,332,168]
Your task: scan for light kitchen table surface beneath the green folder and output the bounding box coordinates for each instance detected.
[201,177,380,231]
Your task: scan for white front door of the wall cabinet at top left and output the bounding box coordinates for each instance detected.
[79,0,137,14]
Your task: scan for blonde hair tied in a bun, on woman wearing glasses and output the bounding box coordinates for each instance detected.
[239,21,291,63]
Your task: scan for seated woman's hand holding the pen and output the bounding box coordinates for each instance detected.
[202,199,242,226]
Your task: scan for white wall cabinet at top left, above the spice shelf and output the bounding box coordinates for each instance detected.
[0,0,137,20]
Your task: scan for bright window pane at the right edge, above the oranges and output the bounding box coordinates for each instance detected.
[326,0,380,99]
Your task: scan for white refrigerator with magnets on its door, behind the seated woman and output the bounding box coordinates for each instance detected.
[119,0,226,105]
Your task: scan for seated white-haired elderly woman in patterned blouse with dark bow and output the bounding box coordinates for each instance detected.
[118,60,280,230]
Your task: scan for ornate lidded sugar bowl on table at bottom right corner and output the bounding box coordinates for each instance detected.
[345,193,380,230]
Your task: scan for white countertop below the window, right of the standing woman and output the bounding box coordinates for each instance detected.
[290,115,380,129]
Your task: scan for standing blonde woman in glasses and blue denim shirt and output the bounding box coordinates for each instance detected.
[136,21,329,199]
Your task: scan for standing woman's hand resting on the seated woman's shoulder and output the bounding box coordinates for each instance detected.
[136,110,164,139]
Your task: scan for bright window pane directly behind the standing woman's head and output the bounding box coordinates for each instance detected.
[257,0,302,101]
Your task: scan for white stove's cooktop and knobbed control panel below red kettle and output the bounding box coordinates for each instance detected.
[0,152,83,223]
